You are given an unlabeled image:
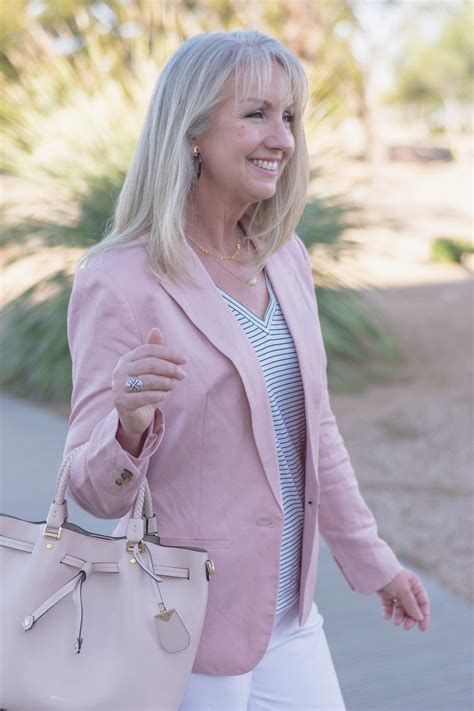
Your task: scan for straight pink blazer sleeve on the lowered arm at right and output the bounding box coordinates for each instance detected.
[297,237,403,594]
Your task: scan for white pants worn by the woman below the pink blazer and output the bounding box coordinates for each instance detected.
[179,602,345,711]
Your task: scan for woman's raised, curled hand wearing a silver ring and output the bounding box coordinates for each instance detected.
[112,328,187,440]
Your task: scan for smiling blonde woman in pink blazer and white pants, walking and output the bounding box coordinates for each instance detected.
[66,30,429,711]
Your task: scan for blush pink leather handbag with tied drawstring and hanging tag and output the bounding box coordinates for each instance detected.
[0,445,214,711]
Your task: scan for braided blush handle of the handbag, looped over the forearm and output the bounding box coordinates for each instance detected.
[43,442,157,545]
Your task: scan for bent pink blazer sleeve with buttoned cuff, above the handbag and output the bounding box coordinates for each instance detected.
[64,263,164,518]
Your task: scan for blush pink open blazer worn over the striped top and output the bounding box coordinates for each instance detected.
[65,235,402,675]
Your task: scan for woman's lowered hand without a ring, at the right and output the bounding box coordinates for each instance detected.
[377,568,430,632]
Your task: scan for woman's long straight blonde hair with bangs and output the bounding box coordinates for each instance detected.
[79,29,309,280]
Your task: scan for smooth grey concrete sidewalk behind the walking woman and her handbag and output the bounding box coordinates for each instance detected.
[0,395,473,711]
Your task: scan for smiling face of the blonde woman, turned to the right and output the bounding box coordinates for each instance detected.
[196,63,295,208]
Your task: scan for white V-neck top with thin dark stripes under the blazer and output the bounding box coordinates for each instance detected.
[217,273,306,613]
